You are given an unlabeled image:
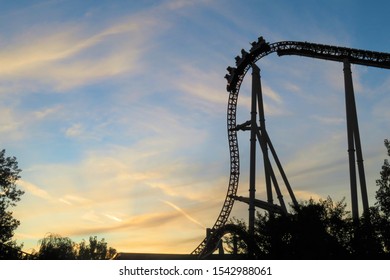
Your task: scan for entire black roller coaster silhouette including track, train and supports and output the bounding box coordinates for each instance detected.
[192,37,390,258]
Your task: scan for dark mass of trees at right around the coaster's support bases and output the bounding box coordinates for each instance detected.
[225,139,390,259]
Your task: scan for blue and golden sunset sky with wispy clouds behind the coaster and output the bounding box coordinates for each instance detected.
[0,0,390,253]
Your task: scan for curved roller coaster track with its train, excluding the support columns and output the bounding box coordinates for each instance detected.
[192,37,390,255]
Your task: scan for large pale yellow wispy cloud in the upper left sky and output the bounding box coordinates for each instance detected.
[0,12,155,91]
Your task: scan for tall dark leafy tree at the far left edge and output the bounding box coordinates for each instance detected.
[0,150,24,259]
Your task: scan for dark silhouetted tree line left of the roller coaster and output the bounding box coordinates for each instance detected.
[0,149,116,260]
